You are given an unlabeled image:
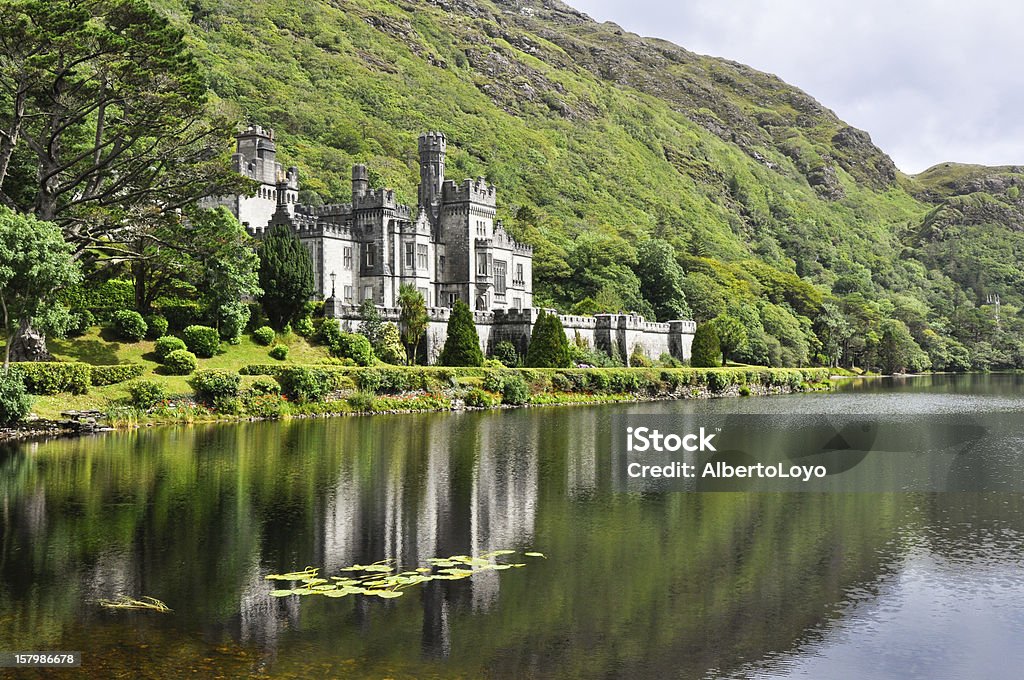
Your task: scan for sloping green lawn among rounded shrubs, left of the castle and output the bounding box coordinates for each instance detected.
[33,328,329,418]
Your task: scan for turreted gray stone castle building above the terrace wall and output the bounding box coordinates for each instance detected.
[212,126,534,311]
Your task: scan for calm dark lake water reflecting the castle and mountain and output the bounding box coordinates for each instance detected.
[0,376,1024,678]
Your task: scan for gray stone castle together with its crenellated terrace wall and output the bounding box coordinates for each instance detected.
[203,126,696,363]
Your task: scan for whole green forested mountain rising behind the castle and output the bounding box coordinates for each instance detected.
[151,0,1024,369]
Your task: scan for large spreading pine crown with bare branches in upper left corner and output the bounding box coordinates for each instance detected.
[0,0,248,253]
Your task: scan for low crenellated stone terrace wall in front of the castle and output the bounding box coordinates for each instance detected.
[324,299,696,364]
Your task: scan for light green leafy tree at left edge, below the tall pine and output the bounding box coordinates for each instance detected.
[0,206,80,366]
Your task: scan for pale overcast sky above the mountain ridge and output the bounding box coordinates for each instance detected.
[567,0,1024,173]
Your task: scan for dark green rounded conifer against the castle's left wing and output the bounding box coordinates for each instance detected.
[259,224,315,331]
